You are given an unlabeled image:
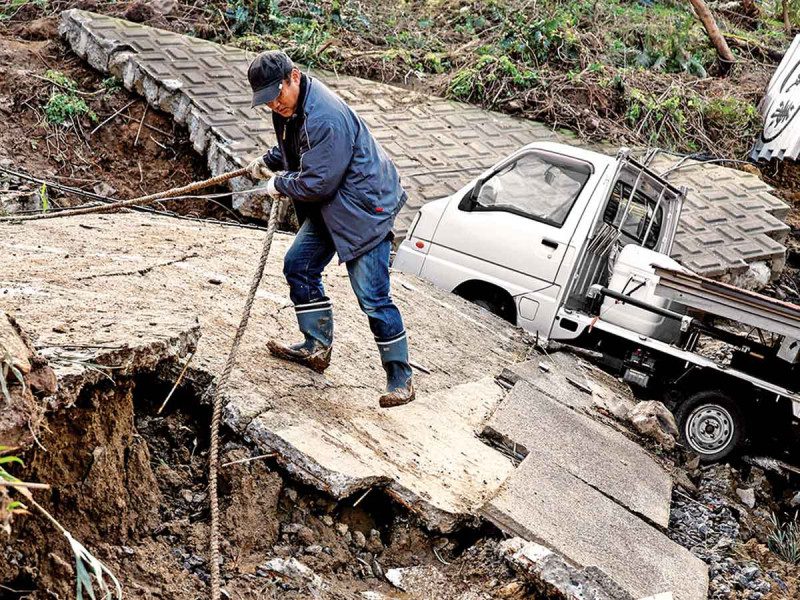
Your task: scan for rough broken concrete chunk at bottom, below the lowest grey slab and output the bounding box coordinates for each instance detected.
[498,537,634,600]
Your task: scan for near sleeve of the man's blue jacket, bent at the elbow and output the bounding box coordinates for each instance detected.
[275,122,353,202]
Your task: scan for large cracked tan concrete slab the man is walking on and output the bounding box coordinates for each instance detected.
[0,213,529,530]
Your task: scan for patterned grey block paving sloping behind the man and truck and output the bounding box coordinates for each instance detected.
[61,10,789,276]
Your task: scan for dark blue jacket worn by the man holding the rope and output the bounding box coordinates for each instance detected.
[264,77,406,262]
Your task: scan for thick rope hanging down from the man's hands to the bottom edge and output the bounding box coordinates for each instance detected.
[208,198,284,600]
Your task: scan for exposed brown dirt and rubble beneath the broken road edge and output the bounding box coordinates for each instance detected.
[0,376,530,600]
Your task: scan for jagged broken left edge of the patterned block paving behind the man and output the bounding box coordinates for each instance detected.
[58,9,271,217]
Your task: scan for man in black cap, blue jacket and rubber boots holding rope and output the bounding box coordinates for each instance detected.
[247,51,414,408]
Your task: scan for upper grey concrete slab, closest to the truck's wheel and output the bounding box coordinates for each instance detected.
[486,381,672,527]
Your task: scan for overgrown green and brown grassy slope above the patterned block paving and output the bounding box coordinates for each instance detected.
[212,0,800,156]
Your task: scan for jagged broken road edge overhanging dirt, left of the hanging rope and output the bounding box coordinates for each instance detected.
[47,324,200,409]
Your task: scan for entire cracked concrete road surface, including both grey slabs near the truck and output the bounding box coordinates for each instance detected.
[0,214,707,599]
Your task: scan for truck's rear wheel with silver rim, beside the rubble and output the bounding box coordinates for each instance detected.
[675,390,745,462]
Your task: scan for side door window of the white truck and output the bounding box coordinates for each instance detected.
[473,153,591,227]
